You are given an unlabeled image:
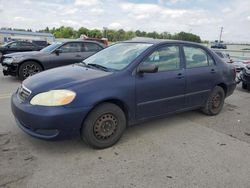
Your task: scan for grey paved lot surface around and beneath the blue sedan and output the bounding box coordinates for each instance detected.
[0,70,250,188]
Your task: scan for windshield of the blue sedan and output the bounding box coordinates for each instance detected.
[84,43,152,70]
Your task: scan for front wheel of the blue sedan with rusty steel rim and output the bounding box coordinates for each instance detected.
[81,103,126,149]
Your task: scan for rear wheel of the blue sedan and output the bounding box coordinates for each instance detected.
[202,86,225,116]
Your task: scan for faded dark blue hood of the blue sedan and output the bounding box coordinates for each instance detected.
[23,64,112,93]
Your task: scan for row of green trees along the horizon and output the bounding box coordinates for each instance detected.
[0,26,201,43]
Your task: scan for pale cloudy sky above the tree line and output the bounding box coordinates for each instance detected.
[0,0,250,42]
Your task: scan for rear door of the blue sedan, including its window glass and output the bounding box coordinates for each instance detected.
[183,46,217,108]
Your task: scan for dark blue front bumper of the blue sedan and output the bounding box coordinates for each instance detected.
[11,93,90,140]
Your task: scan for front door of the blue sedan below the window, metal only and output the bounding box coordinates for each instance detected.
[136,70,185,119]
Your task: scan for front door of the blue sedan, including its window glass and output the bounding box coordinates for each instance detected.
[136,46,185,119]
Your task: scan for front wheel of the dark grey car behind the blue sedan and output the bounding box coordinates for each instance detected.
[18,61,43,80]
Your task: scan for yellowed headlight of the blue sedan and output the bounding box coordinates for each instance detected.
[30,90,76,106]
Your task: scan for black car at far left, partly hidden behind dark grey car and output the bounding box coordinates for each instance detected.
[0,41,44,59]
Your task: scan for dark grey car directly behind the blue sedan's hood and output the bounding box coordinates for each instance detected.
[2,41,104,80]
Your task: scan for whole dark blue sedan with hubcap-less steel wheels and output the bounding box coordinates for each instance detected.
[11,40,236,148]
